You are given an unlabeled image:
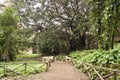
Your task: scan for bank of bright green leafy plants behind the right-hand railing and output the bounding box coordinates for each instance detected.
[70,47,120,67]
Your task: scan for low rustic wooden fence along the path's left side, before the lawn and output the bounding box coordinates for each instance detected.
[0,61,50,77]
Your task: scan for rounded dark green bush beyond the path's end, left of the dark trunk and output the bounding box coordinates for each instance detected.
[38,29,59,55]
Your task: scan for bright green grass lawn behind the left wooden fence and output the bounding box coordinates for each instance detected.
[0,53,46,77]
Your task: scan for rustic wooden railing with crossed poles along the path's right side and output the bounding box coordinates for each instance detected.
[65,57,120,80]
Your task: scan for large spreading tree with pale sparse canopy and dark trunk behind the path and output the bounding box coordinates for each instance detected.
[14,0,89,53]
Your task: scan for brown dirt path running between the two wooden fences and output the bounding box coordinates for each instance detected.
[2,61,89,80]
